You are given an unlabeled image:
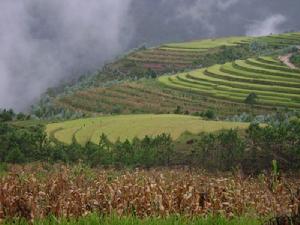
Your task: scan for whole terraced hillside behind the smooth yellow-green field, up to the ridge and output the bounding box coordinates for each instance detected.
[33,33,300,118]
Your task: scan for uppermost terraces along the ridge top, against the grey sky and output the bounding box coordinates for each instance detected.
[127,33,300,71]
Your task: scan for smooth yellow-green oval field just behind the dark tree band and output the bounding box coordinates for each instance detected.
[47,114,249,145]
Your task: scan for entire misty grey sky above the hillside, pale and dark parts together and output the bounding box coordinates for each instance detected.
[0,0,300,110]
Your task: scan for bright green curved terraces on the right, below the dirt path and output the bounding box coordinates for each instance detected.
[159,57,300,108]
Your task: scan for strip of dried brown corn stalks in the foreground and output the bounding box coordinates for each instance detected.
[0,164,300,224]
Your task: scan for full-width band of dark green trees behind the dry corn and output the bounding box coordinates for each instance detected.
[0,118,300,171]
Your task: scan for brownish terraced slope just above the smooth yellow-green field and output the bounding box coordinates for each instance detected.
[55,80,267,117]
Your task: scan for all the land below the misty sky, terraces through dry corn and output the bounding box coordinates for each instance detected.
[0,33,300,225]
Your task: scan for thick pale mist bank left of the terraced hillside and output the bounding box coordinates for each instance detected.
[0,0,132,110]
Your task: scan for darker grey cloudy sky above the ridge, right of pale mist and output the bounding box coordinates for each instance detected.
[130,0,300,44]
